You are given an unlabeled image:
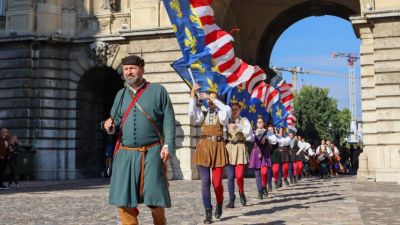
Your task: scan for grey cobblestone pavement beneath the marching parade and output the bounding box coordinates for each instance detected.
[0,177,400,225]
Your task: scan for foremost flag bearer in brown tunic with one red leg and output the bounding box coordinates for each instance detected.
[189,84,231,224]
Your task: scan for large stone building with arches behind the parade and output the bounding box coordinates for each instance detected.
[0,0,400,183]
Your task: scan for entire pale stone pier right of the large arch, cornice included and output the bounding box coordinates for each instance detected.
[352,0,400,184]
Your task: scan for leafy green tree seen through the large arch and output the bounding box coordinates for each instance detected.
[294,86,350,143]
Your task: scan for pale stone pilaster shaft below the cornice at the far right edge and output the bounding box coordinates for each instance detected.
[369,14,400,181]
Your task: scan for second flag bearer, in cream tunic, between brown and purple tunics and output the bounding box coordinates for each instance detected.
[226,103,252,208]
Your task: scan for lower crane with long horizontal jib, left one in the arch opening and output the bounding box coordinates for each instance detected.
[271,66,347,92]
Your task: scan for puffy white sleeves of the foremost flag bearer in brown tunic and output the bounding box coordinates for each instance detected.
[189,98,232,126]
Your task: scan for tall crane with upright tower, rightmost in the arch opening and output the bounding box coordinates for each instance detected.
[332,52,360,121]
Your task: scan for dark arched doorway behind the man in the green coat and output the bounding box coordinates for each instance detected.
[75,66,123,177]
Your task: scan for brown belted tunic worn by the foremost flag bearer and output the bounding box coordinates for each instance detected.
[193,115,228,168]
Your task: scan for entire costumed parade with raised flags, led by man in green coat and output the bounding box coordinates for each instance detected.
[102,0,360,225]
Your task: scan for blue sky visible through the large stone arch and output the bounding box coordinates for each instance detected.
[270,16,361,118]
